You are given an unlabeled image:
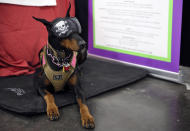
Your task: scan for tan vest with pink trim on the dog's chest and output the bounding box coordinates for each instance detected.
[41,45,77,92]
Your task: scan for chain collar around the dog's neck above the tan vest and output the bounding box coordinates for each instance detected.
[46,43,73,69]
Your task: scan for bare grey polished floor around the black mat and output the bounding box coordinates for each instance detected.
[0,67,190,131]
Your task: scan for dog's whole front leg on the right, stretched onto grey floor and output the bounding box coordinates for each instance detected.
[69,74,95,128]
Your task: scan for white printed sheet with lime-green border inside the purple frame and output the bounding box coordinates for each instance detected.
[93,0,173,62]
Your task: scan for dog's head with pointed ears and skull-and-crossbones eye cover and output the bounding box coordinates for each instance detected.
[33,6,86,51]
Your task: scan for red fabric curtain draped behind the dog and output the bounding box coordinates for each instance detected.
[0,0,75,76]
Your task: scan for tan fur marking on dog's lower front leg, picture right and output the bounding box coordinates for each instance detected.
[77,99,95,128]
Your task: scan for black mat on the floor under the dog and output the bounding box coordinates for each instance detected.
[0,57,147,114]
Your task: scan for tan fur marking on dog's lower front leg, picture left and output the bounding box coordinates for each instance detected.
[44,90,59,120]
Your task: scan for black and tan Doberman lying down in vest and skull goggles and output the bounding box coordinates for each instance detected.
[33,5,95,128]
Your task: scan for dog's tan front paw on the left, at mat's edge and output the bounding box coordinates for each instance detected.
[47,104,60,121]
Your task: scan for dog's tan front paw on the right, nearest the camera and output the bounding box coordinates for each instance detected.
[81,113,95,129]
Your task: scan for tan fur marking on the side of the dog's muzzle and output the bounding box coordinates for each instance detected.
[61,39,79,51]
